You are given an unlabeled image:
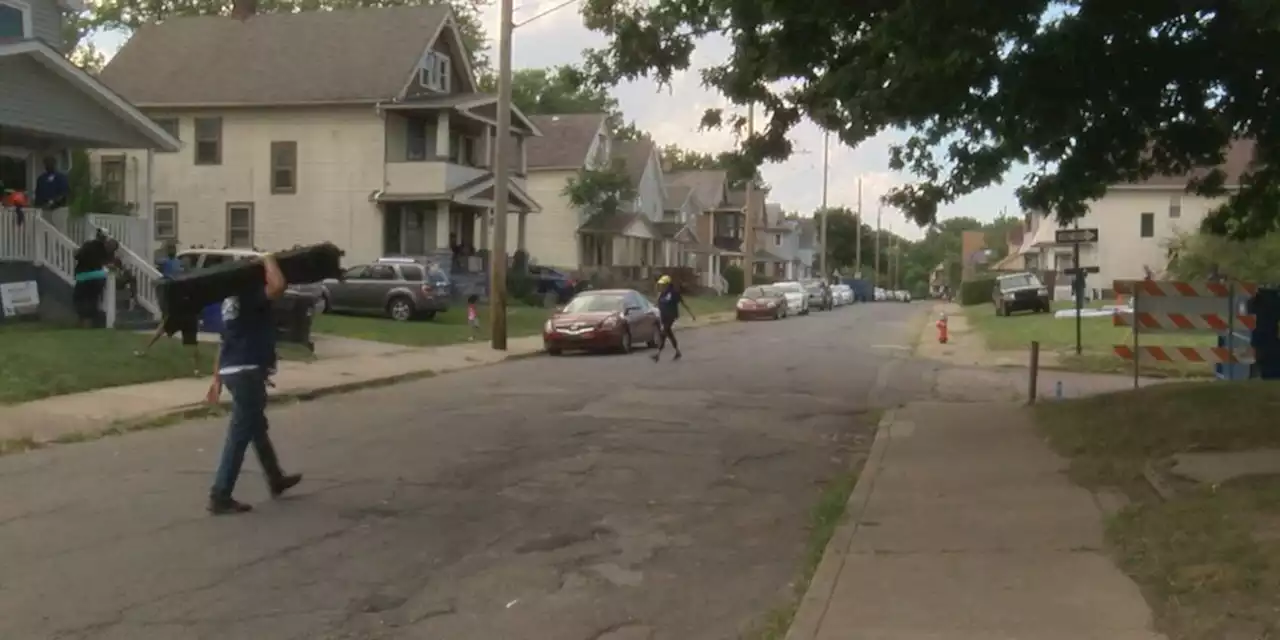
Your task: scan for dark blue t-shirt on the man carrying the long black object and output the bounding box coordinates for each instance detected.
[219,284,275,374]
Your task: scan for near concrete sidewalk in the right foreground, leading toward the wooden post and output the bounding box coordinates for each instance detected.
[787,403,1162,640]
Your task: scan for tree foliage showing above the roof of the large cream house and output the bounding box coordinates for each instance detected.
[76,0,493,70]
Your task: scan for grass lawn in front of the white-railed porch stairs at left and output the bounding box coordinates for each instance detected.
[0,323,306,404]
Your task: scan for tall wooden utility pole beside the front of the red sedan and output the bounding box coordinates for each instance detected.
[489,0,515,351]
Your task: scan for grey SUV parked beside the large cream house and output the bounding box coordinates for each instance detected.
[321,259,449,323]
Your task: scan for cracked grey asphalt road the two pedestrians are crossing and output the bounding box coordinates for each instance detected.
[0,303,933,640]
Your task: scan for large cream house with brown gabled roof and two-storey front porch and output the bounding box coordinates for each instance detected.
[93,3,540,270]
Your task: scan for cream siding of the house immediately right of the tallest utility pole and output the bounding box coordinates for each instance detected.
[519,170,582,269]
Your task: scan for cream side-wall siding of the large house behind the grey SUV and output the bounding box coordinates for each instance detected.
[92,108,385,262]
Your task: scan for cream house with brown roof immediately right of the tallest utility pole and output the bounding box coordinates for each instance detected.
[514,114,613,271]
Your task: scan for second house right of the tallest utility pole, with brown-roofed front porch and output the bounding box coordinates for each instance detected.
[577,140,673,278]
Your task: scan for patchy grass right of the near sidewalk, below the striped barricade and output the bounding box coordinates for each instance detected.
[1036,381,1280,640]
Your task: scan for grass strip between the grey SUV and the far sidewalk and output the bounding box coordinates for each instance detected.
[311,305,552,347]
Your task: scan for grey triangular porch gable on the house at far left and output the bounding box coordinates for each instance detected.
[0,40,179,151]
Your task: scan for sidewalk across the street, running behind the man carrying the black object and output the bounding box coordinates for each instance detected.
[0,335,543,443]
